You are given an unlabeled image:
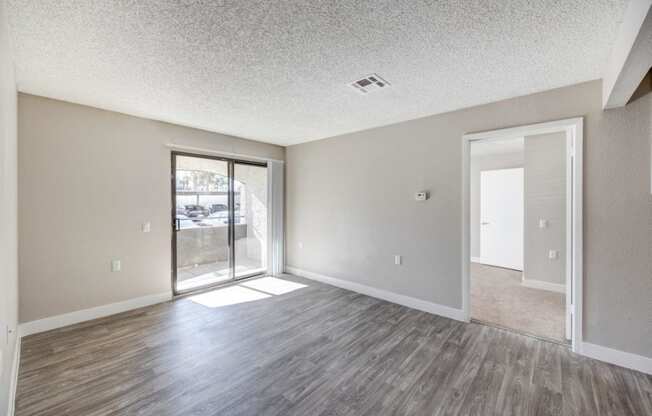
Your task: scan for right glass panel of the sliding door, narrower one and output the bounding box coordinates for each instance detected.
[233,162,267,279]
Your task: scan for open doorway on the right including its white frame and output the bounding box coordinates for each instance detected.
[462,118,583,351]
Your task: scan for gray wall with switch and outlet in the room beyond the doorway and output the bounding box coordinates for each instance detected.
[523,133,566,284]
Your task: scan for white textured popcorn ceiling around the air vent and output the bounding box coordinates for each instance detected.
[10,0,626,145]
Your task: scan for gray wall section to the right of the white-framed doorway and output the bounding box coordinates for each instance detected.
[584,94,652,357]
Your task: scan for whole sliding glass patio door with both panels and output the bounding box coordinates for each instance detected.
[172,152,267,293]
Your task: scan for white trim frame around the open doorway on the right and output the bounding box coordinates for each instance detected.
[462,117,584,353]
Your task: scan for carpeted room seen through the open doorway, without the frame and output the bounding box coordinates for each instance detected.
[470,132,571,343]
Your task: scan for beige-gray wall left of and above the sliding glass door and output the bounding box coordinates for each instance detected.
[18,94,285,322]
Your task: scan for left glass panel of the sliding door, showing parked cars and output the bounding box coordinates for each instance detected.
[173,154,233,293]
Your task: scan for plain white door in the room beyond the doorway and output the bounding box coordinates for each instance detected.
[480,168,524,270]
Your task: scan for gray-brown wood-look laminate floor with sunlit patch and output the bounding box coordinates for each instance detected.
[16,276,652,416]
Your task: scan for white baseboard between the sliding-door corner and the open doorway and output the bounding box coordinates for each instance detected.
[285,266,465,321]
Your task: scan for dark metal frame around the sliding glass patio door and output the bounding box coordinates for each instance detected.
[170,150,270,296]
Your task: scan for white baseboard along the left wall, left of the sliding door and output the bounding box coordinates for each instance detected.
[18,292,172,337]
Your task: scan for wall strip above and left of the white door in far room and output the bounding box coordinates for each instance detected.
[469,151,523,257]
